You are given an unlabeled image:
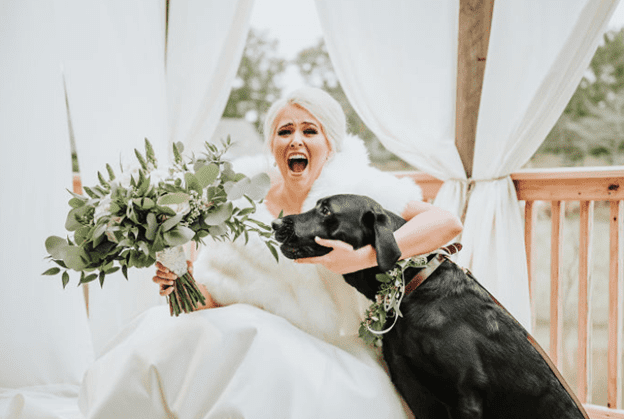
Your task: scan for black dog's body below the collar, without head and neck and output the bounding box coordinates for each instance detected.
[383,261,586,419]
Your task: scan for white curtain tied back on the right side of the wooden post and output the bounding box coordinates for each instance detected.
[458,0,618,326]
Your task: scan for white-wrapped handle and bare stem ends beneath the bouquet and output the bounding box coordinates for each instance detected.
[156,246,206,316]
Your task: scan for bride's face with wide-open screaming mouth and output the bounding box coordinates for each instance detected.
[271,105,331,190]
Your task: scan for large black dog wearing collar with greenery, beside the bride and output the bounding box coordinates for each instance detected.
[273,195,587,419]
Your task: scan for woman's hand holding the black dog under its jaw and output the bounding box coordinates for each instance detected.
[295,237,377,275]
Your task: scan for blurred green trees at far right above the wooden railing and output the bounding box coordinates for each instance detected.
[538,28,624,165]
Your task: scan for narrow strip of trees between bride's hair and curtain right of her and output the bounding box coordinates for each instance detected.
[294,38,409,168]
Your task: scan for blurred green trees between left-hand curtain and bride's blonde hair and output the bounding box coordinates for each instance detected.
[223,28,286,129]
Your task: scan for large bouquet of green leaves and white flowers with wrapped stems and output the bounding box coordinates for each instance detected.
[43,137,278,316]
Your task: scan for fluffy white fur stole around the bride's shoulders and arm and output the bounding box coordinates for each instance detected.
[195,136,422,342]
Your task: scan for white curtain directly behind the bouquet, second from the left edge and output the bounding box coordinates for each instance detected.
[55,0,172,355]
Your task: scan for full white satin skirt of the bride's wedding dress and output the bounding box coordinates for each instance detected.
[79,304,407,419]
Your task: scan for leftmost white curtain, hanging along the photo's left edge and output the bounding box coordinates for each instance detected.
[0,0,93,388]
